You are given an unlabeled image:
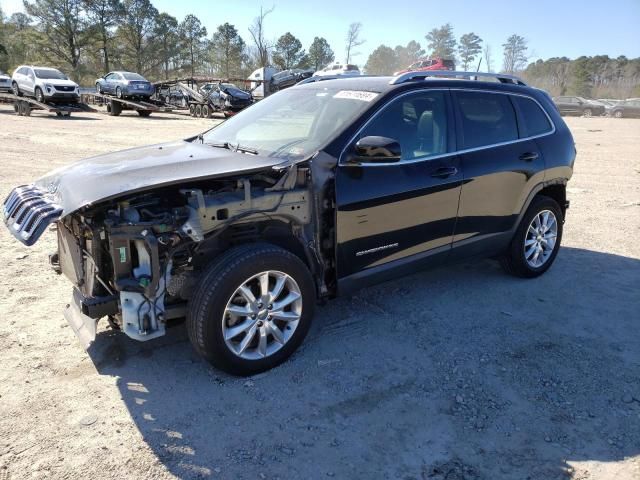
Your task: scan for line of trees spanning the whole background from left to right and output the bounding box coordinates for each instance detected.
[0,0,640,98]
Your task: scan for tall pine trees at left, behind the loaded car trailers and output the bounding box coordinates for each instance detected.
[0,0,344,83]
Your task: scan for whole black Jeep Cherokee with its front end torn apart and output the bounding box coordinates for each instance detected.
[4,72,576,375]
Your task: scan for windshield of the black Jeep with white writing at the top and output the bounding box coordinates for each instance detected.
[203,82,378,160]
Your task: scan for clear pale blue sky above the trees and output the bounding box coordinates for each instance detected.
[0,0,640,68]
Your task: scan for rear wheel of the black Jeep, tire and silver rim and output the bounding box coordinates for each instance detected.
[500,195,564,278]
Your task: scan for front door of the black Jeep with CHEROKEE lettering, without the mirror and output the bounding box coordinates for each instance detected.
[336,90,462,284]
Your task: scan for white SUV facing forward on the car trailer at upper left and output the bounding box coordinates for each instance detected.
[11,65,80,102]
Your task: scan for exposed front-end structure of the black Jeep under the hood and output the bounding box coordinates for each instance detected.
[51,165,334,346]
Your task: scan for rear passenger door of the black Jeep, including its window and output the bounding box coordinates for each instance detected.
[452,90,553,257]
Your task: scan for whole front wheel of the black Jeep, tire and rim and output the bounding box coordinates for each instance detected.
[187,243,316,376]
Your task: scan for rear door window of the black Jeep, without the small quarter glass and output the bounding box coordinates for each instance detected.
[455,91,518,149]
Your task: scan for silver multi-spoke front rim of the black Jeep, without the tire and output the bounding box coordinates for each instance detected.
[222,270,302,360]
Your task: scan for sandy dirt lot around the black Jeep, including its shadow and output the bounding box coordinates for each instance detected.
[0,106,640,480]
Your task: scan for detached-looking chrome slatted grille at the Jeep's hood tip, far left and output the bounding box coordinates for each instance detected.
[2,185,62,245]
